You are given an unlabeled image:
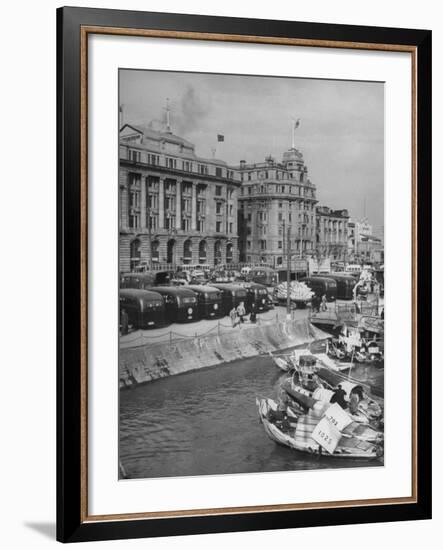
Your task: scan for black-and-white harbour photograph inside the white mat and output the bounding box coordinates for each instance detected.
[118,69,384,479]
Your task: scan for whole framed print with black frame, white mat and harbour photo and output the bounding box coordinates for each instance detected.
[57,8,431,542]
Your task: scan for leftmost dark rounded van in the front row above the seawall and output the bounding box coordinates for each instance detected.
[119,288,165,329]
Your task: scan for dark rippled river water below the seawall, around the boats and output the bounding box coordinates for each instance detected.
[120,357,383,478]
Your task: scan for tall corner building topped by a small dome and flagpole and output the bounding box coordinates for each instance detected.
[236,147,317,267]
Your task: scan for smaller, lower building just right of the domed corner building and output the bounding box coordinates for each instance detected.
[316,206,349,261]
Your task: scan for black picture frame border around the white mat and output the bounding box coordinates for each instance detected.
[57,7,432,542]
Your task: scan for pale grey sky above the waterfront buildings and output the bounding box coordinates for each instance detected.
[120,69,384,228]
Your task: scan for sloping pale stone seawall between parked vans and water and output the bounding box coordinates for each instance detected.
[119,319,329,388]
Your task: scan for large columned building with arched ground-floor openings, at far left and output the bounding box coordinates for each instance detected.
[119,124,241,272]
